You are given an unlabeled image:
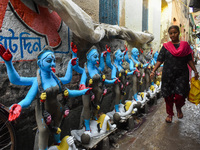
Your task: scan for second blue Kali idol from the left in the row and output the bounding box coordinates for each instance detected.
[79,46,118,142]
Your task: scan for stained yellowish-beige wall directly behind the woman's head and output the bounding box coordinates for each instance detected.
[161,0,190,43]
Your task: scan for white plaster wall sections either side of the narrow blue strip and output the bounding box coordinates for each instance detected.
[120,0,161,51]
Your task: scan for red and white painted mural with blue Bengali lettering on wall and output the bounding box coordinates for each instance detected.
[0,0,71,61]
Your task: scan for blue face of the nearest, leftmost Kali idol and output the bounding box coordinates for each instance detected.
[38,52,56,72]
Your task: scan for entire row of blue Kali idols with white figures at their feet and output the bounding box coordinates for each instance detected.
[0,43,161,150]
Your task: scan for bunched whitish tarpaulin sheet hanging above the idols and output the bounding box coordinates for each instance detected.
[34,0,154,44]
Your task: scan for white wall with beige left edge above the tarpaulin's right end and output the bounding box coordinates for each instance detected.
[119,0,161,51]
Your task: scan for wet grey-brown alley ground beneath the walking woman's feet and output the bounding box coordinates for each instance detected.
[110,65,200,150]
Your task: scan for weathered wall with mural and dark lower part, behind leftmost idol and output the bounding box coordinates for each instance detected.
[0,0,72,150]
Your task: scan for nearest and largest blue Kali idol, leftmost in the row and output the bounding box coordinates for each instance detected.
[0,45,90,150]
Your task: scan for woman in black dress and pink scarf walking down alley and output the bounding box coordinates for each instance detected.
[150,25,199,123]
